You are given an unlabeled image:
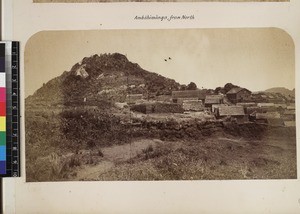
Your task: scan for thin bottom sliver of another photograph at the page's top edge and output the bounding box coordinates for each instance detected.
[33,0,290,3]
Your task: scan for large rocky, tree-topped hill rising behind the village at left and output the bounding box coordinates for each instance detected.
[26,53,181,104]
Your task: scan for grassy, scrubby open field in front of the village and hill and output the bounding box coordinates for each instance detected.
[25,106,297,181]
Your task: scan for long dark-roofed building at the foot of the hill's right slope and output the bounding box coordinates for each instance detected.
[172,90,206,104]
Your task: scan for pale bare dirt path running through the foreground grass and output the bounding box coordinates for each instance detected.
[75,139,162,180]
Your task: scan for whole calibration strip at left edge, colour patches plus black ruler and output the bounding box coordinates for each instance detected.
[0,41,20,177]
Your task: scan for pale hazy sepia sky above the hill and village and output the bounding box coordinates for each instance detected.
[25,28,295,97]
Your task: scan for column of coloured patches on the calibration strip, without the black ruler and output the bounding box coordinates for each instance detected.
[0,43,6,175]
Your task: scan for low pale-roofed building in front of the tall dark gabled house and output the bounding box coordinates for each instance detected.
[216,106,248,123]
